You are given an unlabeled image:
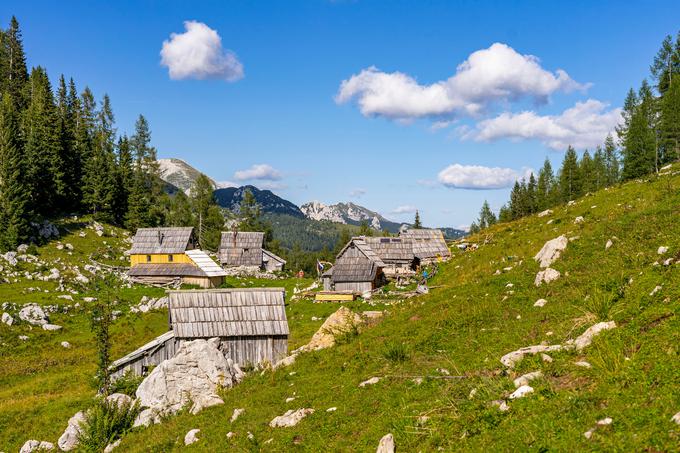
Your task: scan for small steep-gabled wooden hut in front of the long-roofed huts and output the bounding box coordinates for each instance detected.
[324,237,385,298]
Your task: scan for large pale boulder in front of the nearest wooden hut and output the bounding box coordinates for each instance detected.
[136,338,243,415]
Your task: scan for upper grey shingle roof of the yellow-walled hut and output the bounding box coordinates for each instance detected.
[130,227,194,255]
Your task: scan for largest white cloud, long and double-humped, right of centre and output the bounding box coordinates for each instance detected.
[335,43,588,120]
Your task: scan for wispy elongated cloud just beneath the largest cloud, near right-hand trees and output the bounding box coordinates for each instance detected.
[468,99,621,150]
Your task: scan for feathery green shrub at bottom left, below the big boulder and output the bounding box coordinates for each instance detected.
[78,398,141,452]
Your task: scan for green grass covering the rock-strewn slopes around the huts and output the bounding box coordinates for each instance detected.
[0,165,680,452]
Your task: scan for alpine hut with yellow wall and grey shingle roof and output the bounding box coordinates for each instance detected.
[128,227,226,288]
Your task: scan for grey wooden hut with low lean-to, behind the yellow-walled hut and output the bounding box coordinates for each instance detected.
[218,231,286,272]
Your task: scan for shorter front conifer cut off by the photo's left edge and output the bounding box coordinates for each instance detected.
[0,94,29,250]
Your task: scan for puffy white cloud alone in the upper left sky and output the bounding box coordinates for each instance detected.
[161,20,243,82]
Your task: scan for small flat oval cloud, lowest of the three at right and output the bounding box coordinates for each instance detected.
[437,164,524,190]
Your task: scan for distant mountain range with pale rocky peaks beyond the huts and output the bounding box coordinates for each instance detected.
[158,158,467,239]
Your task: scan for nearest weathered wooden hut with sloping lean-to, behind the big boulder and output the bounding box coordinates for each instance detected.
[111,288,289,378]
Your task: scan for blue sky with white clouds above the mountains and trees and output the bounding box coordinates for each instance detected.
[6,0,680,226]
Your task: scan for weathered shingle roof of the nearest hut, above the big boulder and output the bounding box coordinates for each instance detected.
[168,288,289,338]
